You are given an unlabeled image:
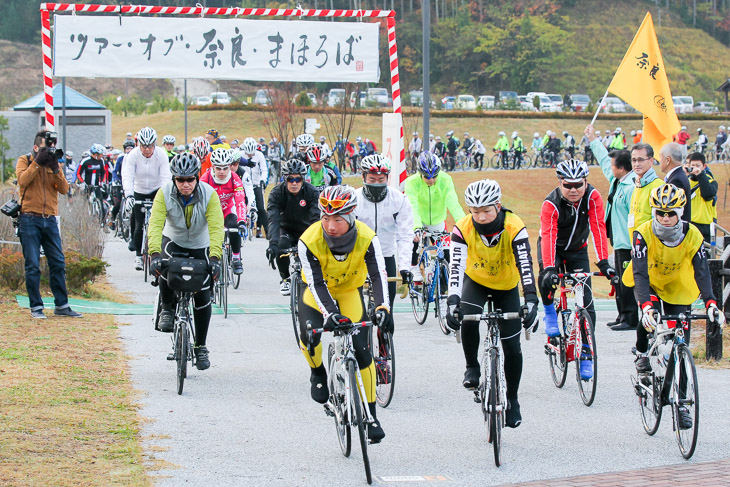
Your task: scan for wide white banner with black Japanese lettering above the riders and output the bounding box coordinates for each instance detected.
[53,15,379,82]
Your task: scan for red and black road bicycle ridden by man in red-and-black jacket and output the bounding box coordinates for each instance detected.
[545,272,602,406]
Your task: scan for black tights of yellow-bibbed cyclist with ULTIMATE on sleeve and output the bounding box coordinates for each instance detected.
[461,275,522,399]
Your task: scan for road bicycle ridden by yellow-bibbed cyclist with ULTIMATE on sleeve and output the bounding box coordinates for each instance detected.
[463,304,521,467]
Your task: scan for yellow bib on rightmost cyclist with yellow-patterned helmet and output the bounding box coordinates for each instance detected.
[622,221,703,305]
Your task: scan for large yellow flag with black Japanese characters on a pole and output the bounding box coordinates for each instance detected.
[608,12,681,154]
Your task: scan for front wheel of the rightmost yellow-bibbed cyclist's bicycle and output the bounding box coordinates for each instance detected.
[671,344,700,459]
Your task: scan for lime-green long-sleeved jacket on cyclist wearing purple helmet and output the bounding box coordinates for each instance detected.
[405,171,466,228]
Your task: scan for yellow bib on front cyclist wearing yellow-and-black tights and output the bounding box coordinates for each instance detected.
[299,220,375,295]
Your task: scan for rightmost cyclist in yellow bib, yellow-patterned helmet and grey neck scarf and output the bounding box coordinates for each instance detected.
[623,184,725,428]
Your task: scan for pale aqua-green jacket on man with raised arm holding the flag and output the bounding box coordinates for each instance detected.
[591,139,636,250]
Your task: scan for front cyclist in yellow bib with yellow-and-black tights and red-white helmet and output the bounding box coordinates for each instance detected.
[298,186,393,443]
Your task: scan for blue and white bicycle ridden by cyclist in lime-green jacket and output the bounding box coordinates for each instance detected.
[408,229,458,339]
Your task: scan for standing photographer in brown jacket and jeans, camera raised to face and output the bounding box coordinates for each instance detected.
[15,131,81,319]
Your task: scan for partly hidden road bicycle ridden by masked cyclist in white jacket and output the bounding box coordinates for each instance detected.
[362,277,401,408]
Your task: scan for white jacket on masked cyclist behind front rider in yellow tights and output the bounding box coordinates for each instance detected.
[355,188,413,270]
